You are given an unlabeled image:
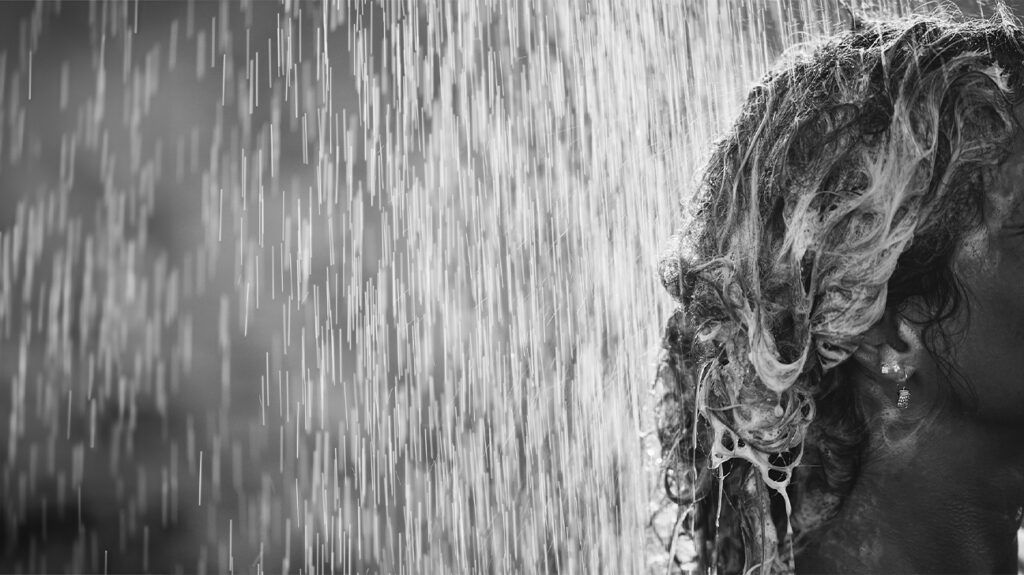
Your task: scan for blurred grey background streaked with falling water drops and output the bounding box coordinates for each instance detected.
[0,0,1024,573]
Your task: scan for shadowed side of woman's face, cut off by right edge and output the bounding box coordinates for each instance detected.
[951,127,1024,429]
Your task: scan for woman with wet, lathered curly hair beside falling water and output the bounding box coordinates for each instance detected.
[659,10,1024,573]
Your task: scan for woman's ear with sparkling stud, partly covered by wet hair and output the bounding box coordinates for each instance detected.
[853,310,926,384]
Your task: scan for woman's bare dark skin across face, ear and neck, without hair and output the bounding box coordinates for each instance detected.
[797,116,1024,573]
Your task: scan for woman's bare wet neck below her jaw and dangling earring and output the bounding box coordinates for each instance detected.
[797,417,1024,573]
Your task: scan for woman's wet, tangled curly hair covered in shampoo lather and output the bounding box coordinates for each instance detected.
[658,10,1024,573]
